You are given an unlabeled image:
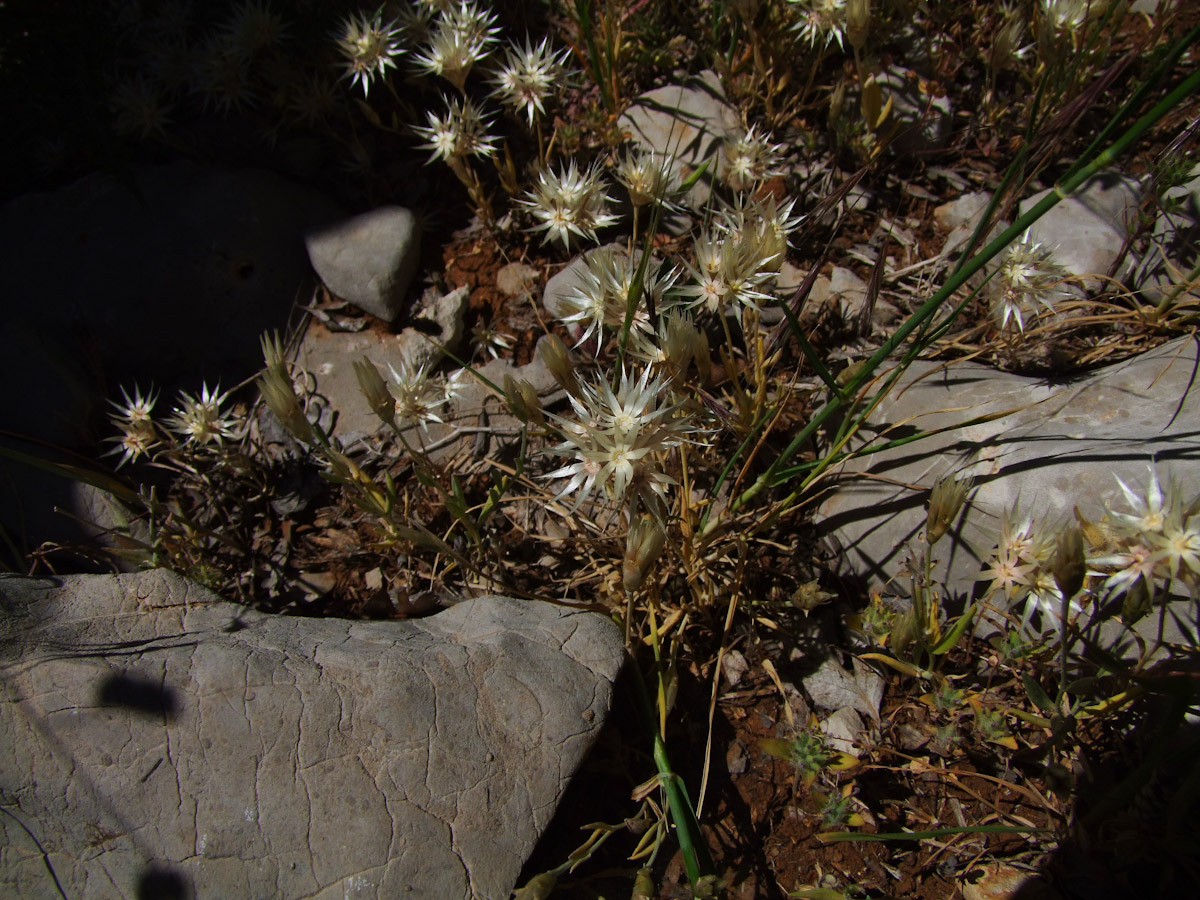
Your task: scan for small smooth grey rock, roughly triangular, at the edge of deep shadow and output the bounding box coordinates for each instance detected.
[305,206,421,322]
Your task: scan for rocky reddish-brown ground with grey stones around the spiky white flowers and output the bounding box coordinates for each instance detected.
[0,5,1200,900]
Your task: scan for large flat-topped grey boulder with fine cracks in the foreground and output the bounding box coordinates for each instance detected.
[0,570,623,900]
